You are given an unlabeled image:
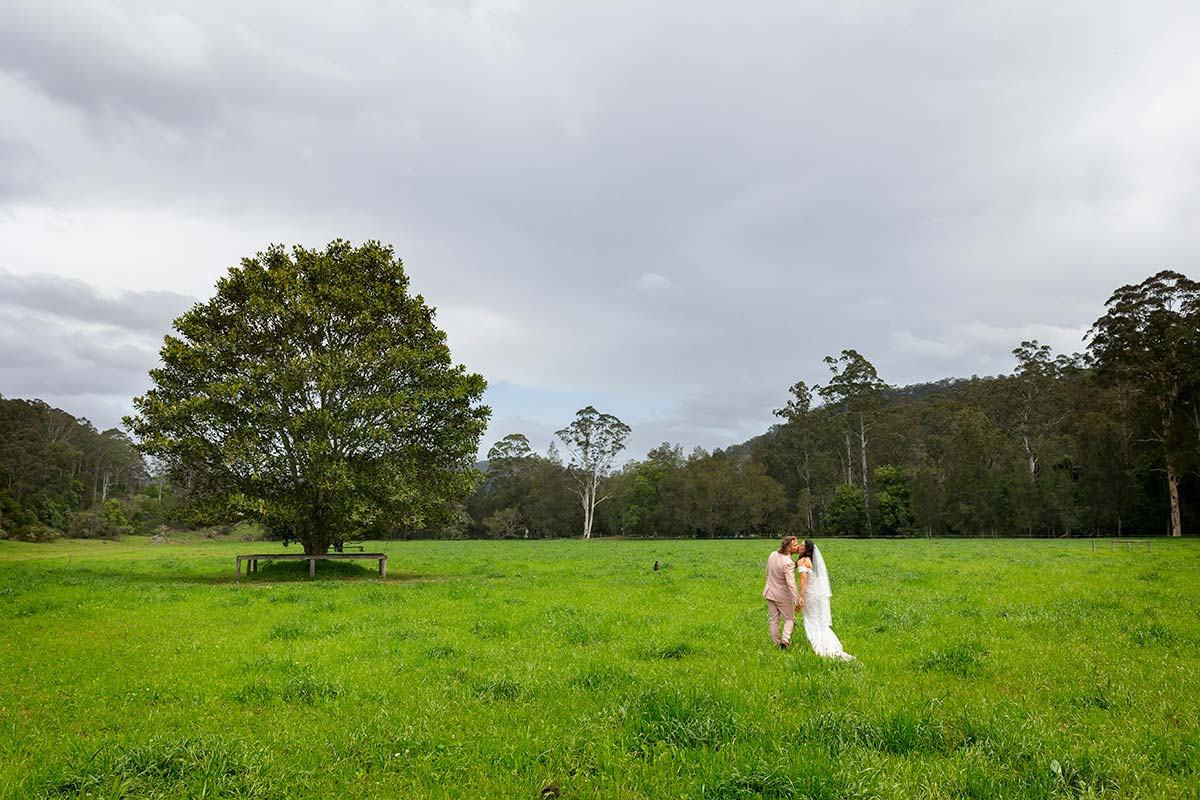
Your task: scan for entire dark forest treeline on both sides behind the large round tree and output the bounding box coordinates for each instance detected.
[0,272,1200,541]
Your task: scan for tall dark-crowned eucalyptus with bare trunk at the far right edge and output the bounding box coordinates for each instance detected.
[1088,270,1200,536]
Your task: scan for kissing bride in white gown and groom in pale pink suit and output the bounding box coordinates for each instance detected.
[762,536,854,661]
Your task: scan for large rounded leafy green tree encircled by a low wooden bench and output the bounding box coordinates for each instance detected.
[125,240,491,553]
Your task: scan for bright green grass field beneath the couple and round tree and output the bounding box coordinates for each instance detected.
[0,539,1200,800]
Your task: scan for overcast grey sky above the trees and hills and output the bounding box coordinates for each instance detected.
[0,0,1200,457]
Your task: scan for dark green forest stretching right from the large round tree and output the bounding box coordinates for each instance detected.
[467,271,1200,537]
